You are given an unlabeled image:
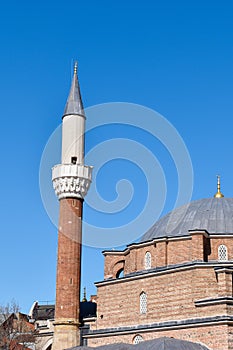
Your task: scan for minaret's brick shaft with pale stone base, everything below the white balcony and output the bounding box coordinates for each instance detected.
[53,198,83,350]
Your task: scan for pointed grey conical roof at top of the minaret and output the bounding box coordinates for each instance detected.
[63,62,85,117]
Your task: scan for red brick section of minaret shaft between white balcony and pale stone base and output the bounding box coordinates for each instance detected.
[56,198,82,320]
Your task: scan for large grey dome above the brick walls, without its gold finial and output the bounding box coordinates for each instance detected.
[141,197,233,242]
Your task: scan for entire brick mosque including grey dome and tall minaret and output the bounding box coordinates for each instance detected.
[31,65,233,350]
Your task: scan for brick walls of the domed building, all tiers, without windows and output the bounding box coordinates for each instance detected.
[94,231,233,350]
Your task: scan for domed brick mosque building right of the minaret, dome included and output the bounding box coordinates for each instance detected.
[85,196,233,350]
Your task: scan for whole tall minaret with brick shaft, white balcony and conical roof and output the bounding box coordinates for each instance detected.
[52,63,92,350]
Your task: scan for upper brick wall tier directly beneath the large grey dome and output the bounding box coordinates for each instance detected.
[104,231,233,278]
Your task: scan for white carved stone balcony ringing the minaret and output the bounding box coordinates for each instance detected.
[52,164,93,199]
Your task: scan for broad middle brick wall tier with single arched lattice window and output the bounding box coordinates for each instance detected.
[96,266,226,329]
